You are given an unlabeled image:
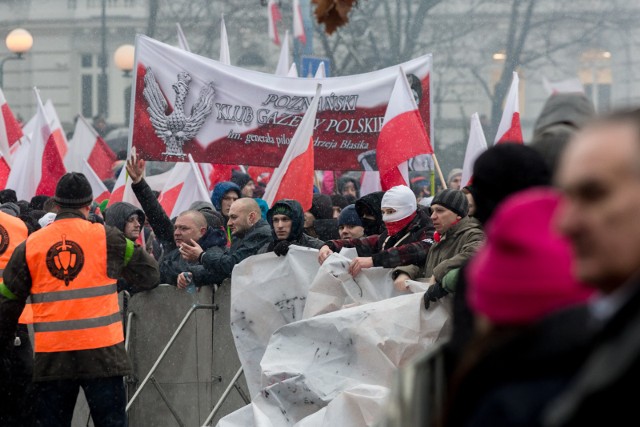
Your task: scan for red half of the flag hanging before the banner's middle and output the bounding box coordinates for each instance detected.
[273,139,314,212]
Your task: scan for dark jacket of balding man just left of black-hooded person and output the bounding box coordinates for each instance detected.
[200,218,273,284]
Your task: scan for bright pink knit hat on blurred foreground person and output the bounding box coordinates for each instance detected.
[467,188,593,324]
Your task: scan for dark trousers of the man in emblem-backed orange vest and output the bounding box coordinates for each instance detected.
[34,377,127,427]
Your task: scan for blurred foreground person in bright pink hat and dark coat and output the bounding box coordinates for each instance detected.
[443,188,593,426]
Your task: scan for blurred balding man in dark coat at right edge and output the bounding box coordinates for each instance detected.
[544,110,640,427]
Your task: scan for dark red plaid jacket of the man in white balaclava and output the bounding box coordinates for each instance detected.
[327,209,433,268]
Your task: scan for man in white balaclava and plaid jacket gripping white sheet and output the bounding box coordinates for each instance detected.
[318,185,433,276]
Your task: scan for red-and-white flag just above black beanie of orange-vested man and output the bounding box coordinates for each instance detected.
[7,88,66,200]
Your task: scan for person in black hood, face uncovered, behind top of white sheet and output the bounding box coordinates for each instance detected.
[259,199,324,256]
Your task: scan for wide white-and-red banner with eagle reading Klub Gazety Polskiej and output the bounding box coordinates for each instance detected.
[131,35,432,170]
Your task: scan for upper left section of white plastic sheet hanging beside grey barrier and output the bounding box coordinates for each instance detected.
[231,246,320,396]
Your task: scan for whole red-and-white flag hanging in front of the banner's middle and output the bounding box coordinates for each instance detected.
[262,84,322,212]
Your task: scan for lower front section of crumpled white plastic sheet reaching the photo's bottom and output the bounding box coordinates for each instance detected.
[218,294,450,427]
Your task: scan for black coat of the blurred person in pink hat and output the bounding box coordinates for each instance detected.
[444,305,596,427]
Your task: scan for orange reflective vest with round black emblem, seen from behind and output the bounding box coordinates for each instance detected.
[26,218,124,353]
